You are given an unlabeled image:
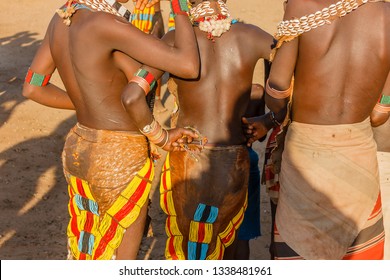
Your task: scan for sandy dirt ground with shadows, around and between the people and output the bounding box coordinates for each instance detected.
[0,0,283,260]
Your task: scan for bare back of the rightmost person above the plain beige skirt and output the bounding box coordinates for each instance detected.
[289,1,390,124]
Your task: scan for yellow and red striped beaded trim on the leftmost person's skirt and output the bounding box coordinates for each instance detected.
[67,158,154,260]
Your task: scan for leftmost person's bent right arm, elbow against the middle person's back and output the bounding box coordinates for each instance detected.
[101,11,200,78]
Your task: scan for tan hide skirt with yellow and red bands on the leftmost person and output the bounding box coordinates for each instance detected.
[63,124,154,260]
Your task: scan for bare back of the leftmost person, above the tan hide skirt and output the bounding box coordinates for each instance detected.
[49,9,141,130]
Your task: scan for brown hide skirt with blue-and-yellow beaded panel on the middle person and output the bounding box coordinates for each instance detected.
[160,146,249,260]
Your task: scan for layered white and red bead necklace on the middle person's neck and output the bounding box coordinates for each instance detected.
[190,0,238,41]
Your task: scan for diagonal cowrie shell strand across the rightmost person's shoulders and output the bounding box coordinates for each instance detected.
[270,0,384,61]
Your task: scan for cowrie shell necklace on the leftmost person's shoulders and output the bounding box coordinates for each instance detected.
[56,0,131,26]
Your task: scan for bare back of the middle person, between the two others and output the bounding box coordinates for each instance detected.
[176,23,272,145]
